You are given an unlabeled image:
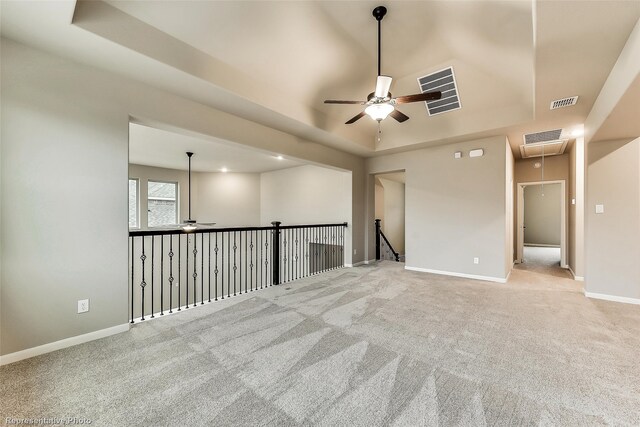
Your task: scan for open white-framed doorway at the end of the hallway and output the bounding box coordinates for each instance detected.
[516,180,568,268]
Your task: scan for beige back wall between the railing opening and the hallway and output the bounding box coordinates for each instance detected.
[367,137,510,280]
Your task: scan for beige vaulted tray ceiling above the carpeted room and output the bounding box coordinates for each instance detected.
[2,1,640,157]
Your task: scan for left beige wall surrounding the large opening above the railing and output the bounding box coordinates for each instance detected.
[0,38,366,355]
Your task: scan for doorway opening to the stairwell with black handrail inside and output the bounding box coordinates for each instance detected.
[375,170,406,262]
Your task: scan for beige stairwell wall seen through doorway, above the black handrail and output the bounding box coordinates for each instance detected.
[380,178,405,255]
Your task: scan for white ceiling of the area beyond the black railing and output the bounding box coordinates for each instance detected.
[129,123,303,173]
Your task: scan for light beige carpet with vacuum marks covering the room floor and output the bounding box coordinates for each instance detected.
[0,262,640,427]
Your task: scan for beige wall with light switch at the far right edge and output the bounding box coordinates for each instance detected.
[585,138,640,300]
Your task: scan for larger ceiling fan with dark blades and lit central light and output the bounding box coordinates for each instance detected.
[324,6,442,125]
